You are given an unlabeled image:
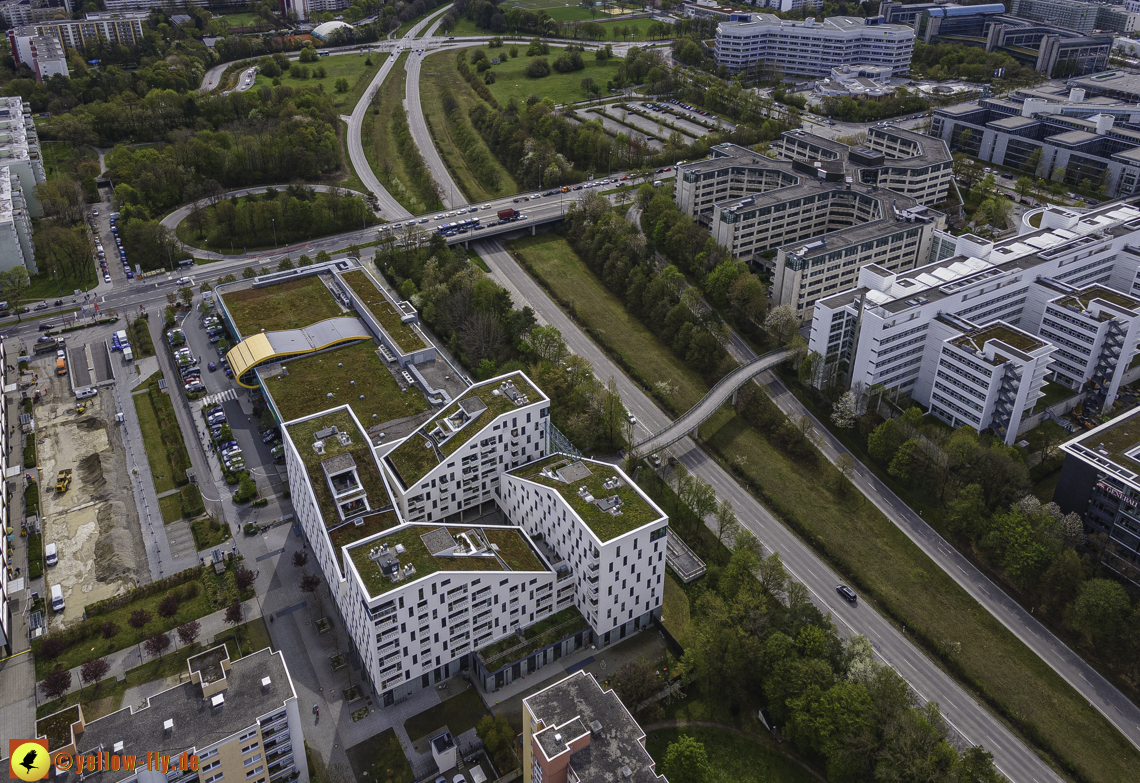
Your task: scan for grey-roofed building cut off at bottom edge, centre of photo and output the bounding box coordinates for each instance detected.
[522,670,667,783]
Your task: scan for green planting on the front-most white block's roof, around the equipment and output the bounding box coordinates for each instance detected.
[349,524,545,596]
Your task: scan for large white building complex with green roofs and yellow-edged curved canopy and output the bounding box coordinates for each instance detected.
[229,264,668,705]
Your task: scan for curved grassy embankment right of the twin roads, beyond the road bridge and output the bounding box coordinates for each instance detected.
[420,50,519,203]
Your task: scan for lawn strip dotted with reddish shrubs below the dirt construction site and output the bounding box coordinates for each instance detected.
[35,565,253,679]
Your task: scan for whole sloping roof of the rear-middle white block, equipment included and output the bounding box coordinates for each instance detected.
[388,373,546,487]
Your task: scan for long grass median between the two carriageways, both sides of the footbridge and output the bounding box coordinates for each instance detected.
[511,227,1140,783]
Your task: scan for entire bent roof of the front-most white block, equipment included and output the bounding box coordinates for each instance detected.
[349,524,546,597]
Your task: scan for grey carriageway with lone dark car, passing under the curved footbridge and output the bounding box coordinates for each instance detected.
[475,240,1061,783]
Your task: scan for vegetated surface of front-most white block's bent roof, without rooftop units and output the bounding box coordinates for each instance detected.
[349,524,548,597]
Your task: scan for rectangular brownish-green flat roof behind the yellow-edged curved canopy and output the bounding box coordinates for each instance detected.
[222,275,344,339]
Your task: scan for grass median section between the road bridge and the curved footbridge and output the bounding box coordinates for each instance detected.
[507,234,708,411]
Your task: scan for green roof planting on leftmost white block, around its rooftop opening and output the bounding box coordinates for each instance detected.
[288,409,392,528]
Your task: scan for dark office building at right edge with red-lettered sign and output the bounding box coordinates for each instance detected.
[1053,408,1140,585]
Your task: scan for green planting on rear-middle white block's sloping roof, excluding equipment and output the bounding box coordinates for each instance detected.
[388,373,546,487]
